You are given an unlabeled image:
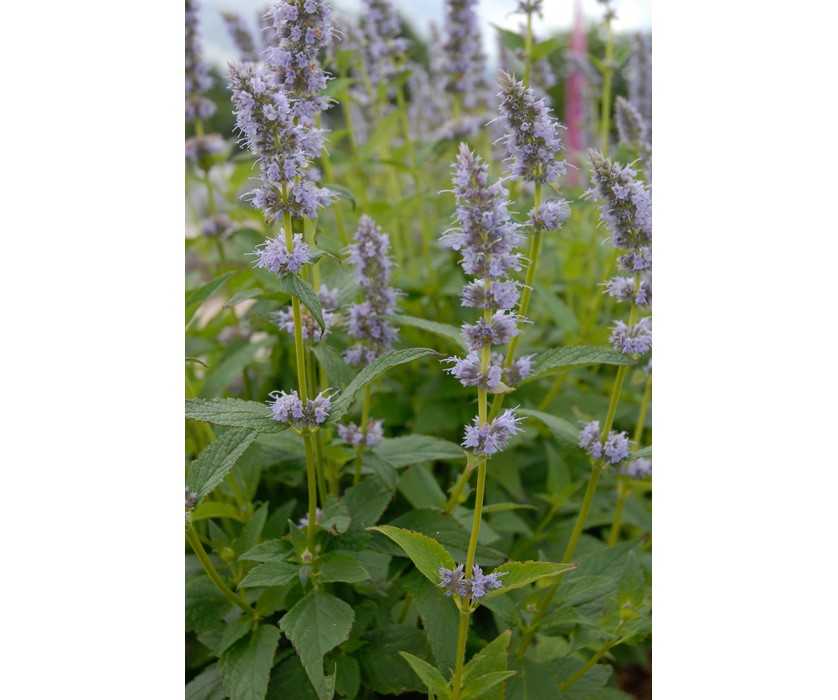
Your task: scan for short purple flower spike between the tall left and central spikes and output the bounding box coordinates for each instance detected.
[344,214,398,365]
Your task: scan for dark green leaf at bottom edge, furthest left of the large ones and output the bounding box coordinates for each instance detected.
[218,625,279,700]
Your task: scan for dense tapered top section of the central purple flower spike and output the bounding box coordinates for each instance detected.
[441,143,521,279]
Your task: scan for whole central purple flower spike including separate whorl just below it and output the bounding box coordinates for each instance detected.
[441,144,530,456]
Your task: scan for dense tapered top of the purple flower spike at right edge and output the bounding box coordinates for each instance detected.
[588,150,652,249]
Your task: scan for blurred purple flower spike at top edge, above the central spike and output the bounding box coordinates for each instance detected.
[442,0,489,110]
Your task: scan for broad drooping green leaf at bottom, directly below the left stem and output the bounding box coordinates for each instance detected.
[279,591,355,700]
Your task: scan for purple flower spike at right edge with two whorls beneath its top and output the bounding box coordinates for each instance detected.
[588,150,652,355]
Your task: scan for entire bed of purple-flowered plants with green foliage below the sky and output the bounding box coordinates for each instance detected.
[186,0,651,700]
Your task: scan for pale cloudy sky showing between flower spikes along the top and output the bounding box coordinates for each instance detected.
[198,0,652,67]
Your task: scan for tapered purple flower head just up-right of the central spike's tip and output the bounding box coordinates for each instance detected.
[498,70,566,183]
